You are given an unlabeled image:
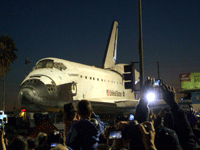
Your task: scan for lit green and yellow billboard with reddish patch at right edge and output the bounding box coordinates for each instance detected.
[180,72,200,90]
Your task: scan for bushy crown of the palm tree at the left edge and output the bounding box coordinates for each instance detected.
[0,34,17,79]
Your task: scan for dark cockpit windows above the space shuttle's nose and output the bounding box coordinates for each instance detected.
[33,59,67,71]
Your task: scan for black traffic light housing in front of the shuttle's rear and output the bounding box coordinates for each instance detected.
[124,64,135,90]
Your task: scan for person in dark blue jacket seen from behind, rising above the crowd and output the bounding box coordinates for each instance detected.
[66,100,104,150]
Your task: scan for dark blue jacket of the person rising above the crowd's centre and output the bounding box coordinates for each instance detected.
[66,113,104,150]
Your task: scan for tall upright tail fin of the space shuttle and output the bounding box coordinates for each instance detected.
[102,21,118,68]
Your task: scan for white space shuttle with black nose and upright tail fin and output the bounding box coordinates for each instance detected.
[18,21,139,111]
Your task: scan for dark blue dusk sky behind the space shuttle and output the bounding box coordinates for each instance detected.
[0,0,200,110]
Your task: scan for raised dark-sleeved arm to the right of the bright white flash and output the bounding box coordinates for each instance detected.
[160,83,196,150]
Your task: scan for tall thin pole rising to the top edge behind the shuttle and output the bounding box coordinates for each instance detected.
[138,0,144,90]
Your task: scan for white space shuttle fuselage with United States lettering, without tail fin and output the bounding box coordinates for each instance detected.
[20,58,138,111]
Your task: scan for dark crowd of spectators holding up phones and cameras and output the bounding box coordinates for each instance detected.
[0,78,200,150]
